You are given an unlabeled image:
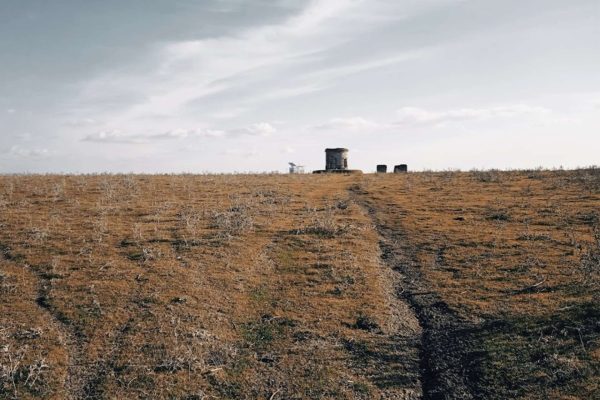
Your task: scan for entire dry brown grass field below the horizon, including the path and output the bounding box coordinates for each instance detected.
[0,169,600,400]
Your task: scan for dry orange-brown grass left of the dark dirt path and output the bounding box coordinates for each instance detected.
[0,176,419,399]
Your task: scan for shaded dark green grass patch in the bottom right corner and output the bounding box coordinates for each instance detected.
[472,304,600,398]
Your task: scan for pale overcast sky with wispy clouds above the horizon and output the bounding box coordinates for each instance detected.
[0,0,600,172]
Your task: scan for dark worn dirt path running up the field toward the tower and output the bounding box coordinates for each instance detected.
[350,184,476,399]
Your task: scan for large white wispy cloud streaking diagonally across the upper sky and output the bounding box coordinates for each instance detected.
[69,0,457,136]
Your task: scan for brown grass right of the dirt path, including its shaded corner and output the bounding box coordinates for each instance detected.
[360,169,600,399]
